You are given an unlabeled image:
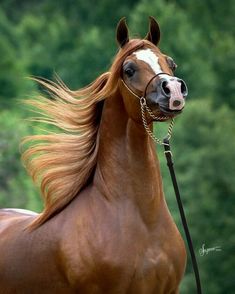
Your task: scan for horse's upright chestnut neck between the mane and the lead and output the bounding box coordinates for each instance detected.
[94,92,163,223]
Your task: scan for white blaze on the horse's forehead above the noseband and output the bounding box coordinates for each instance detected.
[134,48,162,74]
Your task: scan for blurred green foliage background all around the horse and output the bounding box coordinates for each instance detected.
[0,0,235,294]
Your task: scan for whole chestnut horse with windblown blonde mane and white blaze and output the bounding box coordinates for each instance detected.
[0,18,186,294]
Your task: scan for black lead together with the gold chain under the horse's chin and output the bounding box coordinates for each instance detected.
[140,97,202,294]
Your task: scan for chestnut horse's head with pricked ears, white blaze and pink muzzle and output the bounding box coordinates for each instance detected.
[116,17,188,122]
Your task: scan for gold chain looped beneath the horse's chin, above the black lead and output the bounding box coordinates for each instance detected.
[140,97,174,145]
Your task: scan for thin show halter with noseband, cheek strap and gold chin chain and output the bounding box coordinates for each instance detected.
[121,72,174,145]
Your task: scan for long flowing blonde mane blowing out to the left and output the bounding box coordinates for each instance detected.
[22,40,148,229]
